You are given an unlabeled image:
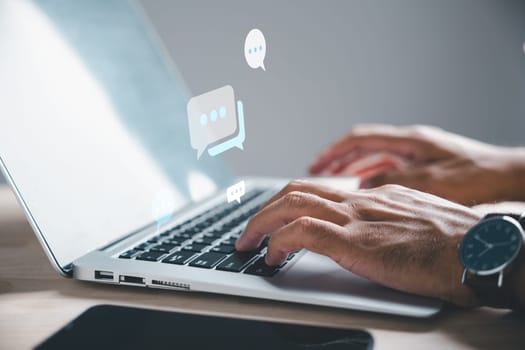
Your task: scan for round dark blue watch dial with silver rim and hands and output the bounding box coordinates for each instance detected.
[460,217,523,275]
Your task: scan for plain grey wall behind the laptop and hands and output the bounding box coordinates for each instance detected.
[0,0,525,181]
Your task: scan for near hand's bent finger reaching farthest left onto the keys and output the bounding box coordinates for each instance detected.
[236,192,348,250]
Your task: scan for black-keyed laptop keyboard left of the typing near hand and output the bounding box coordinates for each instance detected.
[119,190,296,277]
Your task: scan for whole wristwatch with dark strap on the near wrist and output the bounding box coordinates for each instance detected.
[459,213,525,307]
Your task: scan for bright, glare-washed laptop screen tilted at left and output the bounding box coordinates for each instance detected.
[0,0,231,267]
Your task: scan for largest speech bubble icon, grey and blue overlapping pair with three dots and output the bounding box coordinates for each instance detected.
[187,85,246,159]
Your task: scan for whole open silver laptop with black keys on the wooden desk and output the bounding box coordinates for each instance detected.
[0,0,442,317]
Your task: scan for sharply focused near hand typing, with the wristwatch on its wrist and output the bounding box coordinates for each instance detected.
[236,181,481,305]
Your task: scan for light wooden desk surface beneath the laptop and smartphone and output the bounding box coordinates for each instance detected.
[0,186,525,350]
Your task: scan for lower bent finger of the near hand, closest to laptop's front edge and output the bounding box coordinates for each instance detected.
[266,216,351,266]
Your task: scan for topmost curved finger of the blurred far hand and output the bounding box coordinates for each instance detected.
[309,125,429,174]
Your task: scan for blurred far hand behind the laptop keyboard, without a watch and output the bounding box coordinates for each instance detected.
[310,125,525,205]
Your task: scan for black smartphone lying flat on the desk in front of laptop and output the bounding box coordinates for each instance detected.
[36,305,373,350]
